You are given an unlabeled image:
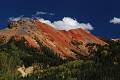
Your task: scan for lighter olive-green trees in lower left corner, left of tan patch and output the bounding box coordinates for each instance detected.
[0,52,21,80]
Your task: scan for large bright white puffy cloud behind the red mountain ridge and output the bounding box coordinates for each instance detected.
[39,17,94,31]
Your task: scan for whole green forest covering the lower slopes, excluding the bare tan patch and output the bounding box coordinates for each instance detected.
[0,38,120,80]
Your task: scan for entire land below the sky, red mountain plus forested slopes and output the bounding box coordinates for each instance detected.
[0,18,120,80]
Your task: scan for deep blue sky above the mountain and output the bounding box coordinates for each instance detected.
[0,0,120,38]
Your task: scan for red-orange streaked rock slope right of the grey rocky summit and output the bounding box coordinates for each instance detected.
[35,22,106,58]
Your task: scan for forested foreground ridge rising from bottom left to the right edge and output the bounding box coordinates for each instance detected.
[26,41,120,80]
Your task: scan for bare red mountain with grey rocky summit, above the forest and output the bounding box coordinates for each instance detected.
[0,18,106,59]
